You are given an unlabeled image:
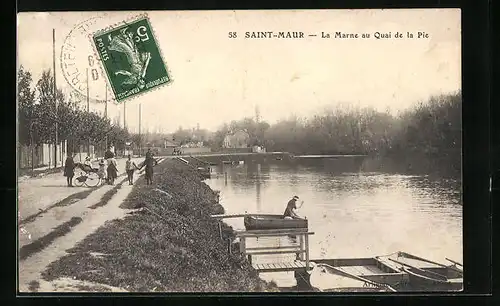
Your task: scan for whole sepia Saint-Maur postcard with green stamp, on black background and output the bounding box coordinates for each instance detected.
[17,9,463,294]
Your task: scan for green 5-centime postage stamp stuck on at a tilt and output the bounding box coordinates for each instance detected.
[93,16,170,102]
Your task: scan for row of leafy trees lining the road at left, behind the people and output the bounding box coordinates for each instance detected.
[17,66,129,158]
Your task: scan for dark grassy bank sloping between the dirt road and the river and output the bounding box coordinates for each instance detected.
[43,160,278,292]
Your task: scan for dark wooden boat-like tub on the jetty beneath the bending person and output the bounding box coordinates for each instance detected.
[243,215,308,230]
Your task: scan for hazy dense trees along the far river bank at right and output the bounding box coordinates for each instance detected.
[213,92,462,158]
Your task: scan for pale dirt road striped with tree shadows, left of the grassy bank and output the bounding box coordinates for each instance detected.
[18,159,163,292]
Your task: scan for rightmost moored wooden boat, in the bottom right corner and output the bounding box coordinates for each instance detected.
[378,252,463,291]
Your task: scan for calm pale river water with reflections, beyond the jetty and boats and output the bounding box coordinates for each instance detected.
[205,157,462,286]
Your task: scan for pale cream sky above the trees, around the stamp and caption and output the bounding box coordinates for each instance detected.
[17,9,461,132]
